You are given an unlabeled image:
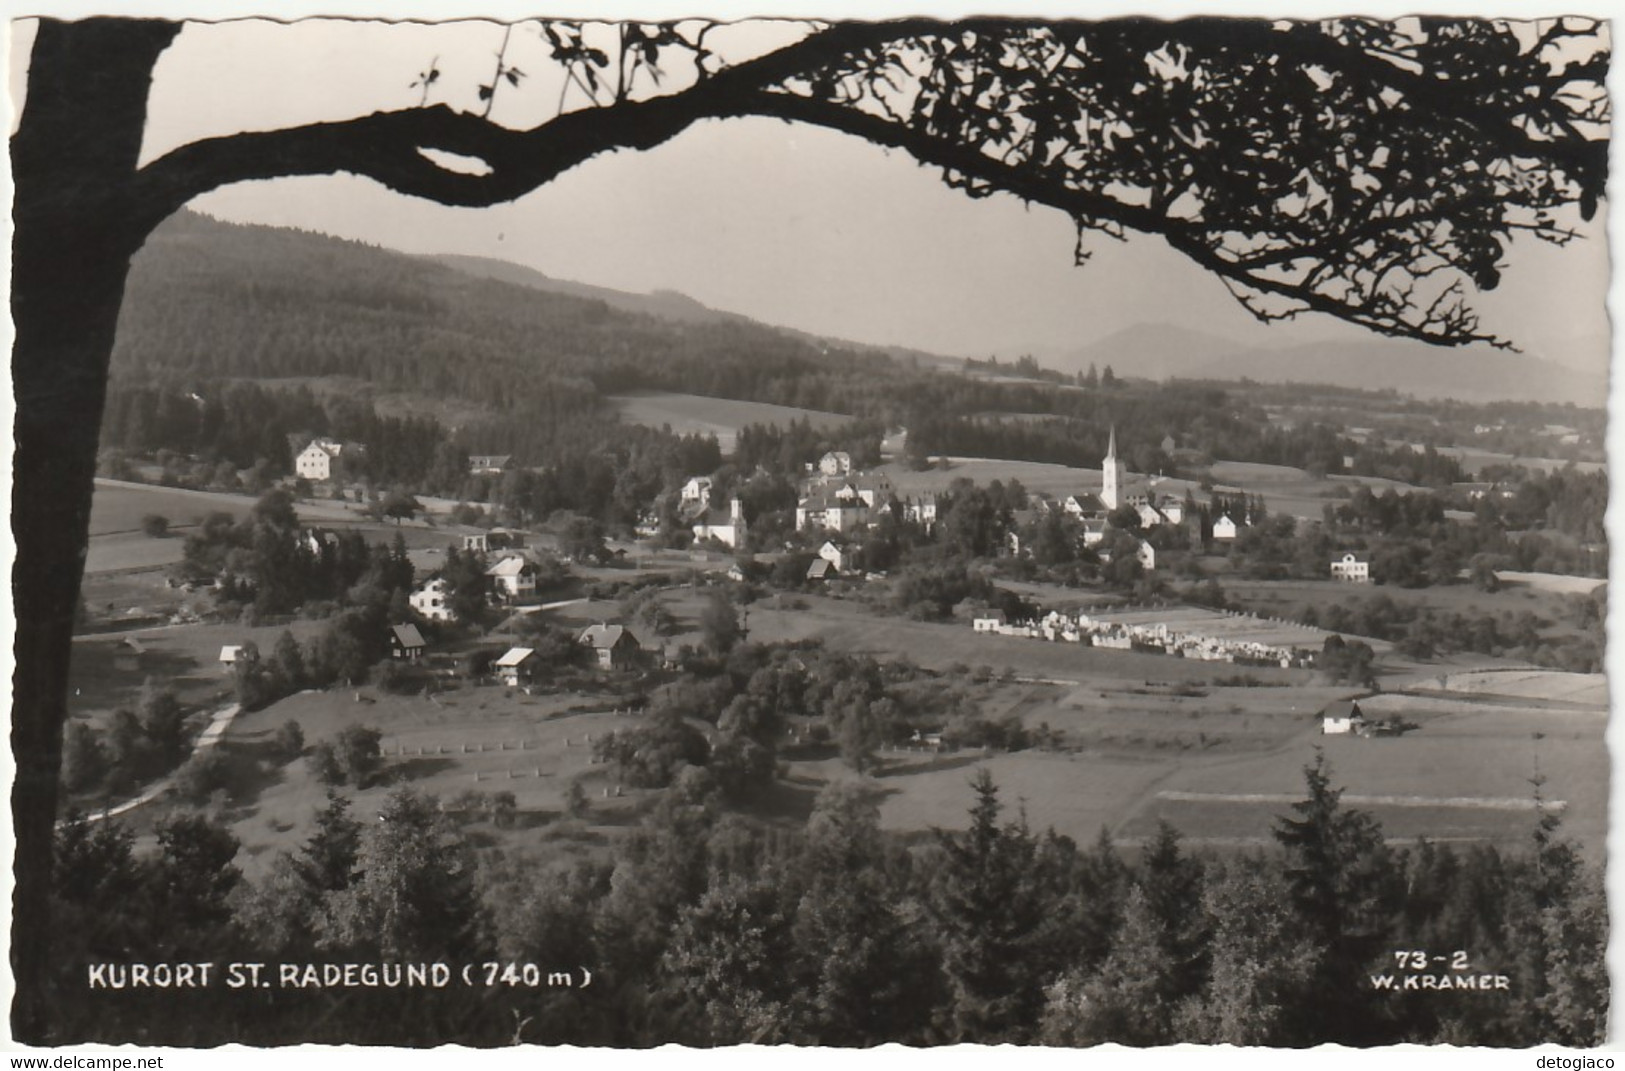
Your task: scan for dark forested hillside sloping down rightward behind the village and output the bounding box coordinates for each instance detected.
[102,213,1589,503]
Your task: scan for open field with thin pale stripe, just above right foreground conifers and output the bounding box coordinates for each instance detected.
[832,676,1609,856]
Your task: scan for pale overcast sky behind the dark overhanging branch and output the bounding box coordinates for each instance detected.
[18,11,1609,371]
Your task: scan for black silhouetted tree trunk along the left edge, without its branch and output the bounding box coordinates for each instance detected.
[11,21,179,1043]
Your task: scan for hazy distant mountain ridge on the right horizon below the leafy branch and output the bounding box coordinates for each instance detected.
[1047,323,1607,408]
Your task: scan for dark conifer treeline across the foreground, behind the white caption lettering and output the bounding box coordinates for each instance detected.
[49,761,1609,1047]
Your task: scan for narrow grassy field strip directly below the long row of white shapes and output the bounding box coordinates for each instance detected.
[749,596,1313,683]
